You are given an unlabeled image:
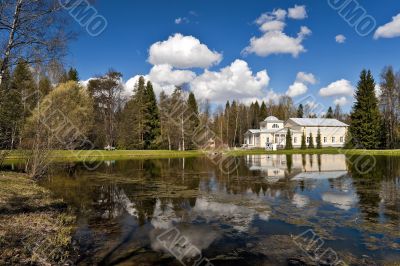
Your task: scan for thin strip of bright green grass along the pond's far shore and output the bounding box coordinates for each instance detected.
[6,148,400,162]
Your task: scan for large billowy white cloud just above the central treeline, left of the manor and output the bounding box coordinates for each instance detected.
[191,59,275,103]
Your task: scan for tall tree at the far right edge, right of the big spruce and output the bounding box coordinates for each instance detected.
[380,66,400,149]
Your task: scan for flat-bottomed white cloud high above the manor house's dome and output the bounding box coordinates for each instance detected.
[243,27,311,57]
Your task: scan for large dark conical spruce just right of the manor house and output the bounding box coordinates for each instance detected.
[349,70,381,149]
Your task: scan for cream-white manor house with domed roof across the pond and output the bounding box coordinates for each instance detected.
[244,116,349,149]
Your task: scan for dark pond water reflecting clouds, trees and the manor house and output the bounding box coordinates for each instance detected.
[21,155,400,265]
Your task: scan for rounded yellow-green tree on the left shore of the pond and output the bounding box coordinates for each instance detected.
[23,81,93,178]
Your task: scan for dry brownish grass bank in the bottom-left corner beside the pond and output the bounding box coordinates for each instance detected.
[0,172,76,265]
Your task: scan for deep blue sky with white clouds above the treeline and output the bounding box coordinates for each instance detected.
[67,0,400,110]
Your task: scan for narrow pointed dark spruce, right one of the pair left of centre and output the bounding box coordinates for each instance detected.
[144,81,160,149]
